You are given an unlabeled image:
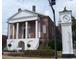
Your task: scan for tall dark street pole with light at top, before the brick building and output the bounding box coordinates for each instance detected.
[48,0,57,59]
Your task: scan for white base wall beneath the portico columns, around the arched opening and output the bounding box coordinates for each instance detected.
[7,38,39,50]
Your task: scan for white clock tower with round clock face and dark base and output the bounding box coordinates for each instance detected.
[59,7,74,57]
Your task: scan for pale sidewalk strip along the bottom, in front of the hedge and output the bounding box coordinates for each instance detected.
[2,56,76,59]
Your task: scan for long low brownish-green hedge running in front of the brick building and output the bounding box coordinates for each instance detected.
[4,49,55,57]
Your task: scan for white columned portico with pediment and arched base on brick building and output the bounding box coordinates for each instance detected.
[7,10,40,50]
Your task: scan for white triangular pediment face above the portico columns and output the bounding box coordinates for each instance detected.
[10,10,38,19]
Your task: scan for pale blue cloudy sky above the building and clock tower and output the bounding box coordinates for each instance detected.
[2,0,76,35]
